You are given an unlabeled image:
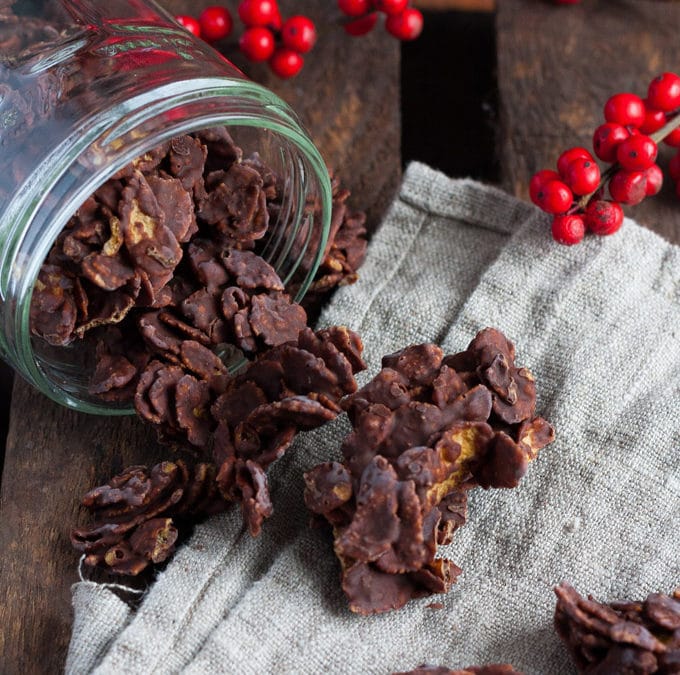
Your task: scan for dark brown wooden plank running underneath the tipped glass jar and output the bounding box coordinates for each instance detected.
[0,0,401,675]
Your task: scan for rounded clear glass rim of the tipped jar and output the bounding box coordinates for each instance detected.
[0,77,332,415]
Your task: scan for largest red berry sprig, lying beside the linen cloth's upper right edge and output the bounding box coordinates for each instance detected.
[529,73,680,245]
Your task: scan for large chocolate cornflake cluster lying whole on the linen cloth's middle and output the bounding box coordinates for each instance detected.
[305,328,554,614]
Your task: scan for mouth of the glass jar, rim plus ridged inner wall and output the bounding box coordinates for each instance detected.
[0,77,332,415]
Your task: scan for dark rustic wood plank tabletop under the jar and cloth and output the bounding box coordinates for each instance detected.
[0,0,680,674]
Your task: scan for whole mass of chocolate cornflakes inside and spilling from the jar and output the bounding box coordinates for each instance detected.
[23,119,365,574]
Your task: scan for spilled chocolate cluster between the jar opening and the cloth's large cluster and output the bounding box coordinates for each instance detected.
[210,326,364,535]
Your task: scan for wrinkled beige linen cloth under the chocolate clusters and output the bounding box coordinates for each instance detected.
[66,164,680,675]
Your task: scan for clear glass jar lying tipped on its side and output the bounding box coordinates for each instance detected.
[0,0,332,414]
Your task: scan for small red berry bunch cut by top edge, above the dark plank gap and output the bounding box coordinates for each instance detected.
[338,0,423,40]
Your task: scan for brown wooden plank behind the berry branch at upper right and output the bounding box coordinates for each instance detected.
[496,0,680,243]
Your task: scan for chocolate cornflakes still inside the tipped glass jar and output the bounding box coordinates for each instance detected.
[31,127,365,362]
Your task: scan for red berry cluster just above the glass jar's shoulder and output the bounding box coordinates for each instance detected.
[175,0,316,79]
